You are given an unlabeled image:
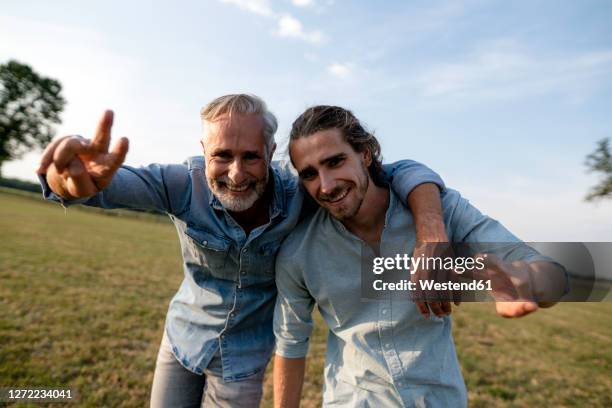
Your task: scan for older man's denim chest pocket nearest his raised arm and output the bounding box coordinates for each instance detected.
[185,225,231,277]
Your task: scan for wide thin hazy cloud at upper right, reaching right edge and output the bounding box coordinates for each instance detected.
[413,41,612,100]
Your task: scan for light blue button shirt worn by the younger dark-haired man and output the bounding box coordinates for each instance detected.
[274,189,547,407]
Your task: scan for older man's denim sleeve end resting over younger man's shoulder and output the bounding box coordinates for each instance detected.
[383,160,445,200]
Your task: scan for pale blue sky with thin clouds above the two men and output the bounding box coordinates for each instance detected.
[0,0,612,242]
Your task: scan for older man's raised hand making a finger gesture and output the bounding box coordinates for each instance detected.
[36,110,129,199]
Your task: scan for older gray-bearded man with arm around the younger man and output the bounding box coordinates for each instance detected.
[38,94,448,407]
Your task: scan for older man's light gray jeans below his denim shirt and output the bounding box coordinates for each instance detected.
[151,331,264,408]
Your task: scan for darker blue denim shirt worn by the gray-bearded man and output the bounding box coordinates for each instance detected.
[40,156,443,381]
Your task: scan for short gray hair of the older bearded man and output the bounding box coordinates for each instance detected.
[200,94,278,159]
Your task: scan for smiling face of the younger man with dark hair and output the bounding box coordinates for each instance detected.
[289,129,371,221]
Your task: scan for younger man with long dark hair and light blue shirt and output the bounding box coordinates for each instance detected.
[274,106,564,408]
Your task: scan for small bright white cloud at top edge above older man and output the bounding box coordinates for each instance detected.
[220,0,325,44]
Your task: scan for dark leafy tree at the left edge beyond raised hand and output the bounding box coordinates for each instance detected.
[0,60,66,175]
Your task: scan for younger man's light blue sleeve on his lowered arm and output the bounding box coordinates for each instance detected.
[274,251,314,358]
